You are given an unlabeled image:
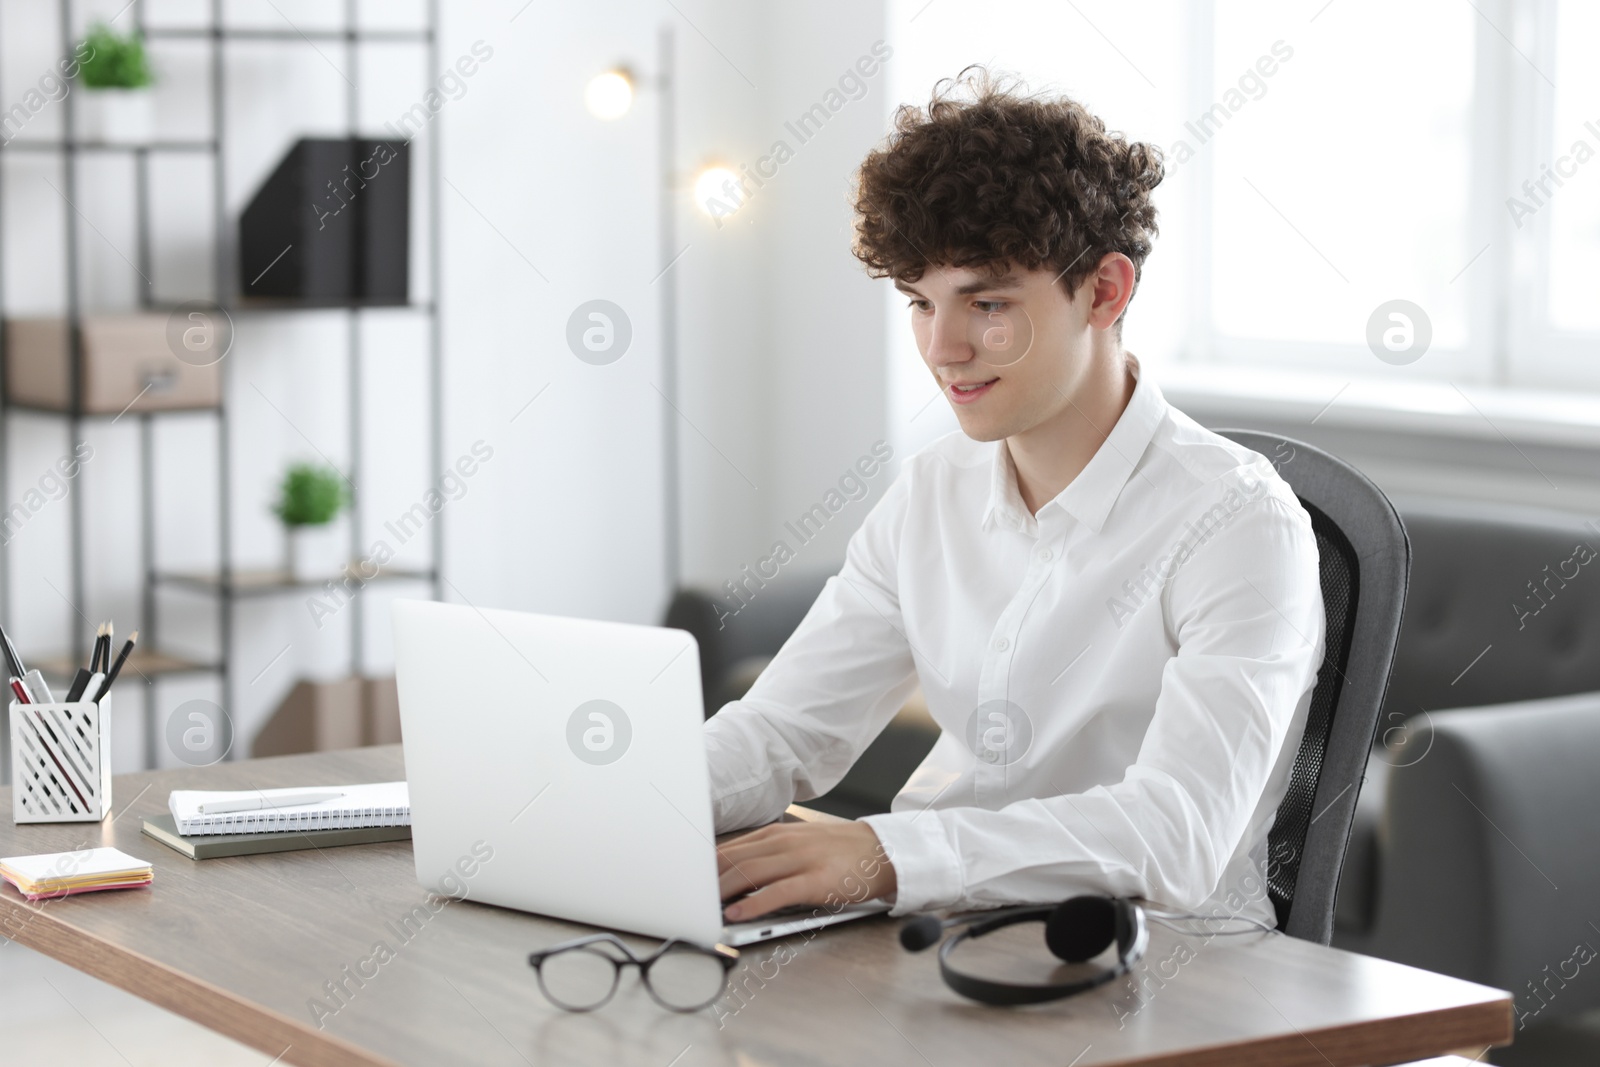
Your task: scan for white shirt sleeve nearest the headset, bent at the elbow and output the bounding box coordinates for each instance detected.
[864,496,1323,915]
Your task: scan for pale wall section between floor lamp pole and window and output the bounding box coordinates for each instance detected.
[677,2,893,589]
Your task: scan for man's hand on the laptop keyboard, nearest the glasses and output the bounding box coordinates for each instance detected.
[717,822,898,923]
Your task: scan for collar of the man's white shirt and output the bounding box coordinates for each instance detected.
[982,354,1166,534]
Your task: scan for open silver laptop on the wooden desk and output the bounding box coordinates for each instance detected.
[392,600,888,945]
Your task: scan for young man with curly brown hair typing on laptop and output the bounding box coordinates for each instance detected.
[706,72,1323,923]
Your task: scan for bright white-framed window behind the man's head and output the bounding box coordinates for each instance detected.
[888,0,1600,446]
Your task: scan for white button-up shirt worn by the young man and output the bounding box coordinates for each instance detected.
[706,357,1323,923]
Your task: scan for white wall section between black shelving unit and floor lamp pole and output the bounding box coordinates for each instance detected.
[443,2,664,622]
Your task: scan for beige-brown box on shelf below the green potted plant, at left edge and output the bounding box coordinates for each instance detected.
[5,314,222,414]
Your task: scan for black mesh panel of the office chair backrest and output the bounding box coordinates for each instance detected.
[1267,499,1360,929]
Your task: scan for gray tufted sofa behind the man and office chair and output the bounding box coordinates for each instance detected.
[669,498,1600,1062]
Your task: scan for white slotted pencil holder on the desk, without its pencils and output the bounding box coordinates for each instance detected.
[11,696,110,822]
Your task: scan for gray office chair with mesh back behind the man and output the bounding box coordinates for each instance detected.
[1218,430,1411,944]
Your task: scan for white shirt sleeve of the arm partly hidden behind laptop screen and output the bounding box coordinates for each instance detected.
[704,470,915,833]
